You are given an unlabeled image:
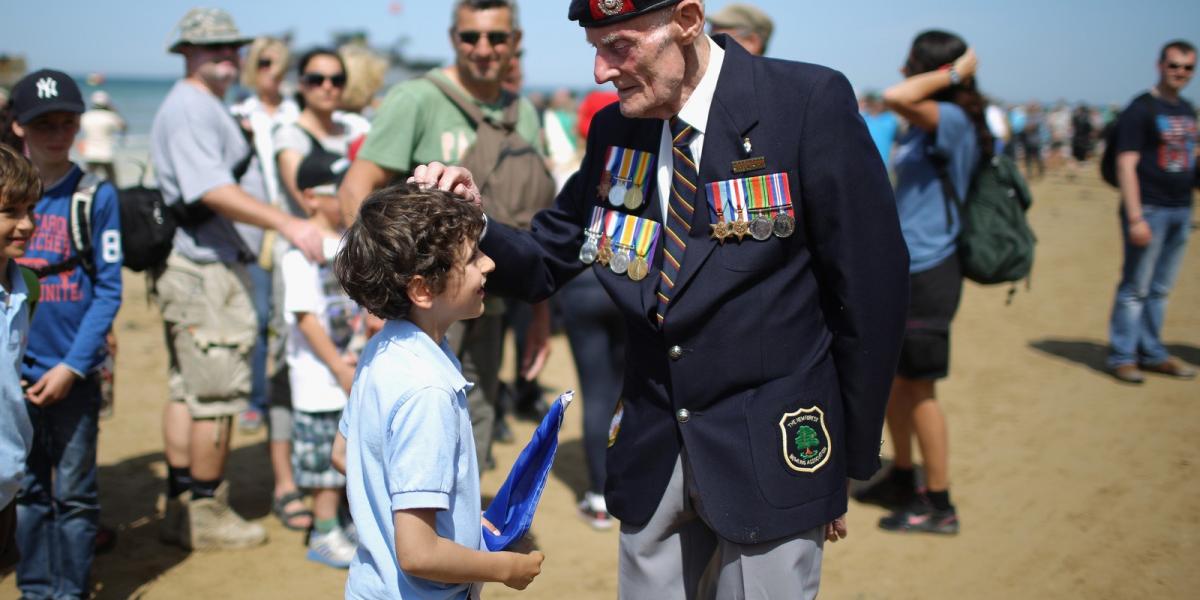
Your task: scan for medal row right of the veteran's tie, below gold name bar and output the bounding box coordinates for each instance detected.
[708,173,796,244]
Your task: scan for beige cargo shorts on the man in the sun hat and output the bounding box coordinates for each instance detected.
[152,252,258,419]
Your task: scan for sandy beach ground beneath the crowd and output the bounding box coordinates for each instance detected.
[0,167,1200,600]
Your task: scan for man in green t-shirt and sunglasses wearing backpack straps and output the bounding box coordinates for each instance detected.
[338,0,550,469]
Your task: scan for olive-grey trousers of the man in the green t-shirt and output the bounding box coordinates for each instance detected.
[446,307,504,472]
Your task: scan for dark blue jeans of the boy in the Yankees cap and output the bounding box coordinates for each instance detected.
[17,377,100,600]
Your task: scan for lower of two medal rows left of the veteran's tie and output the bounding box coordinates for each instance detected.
[580,206,662,281]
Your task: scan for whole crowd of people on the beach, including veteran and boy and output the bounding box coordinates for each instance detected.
[0,0,1200,599]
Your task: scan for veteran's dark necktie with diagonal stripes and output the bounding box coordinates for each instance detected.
[658,116,700,326]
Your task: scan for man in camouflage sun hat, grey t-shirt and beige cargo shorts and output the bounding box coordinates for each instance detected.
[150,8,323,550]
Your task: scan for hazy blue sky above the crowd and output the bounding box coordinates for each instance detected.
[0,0,1200,102]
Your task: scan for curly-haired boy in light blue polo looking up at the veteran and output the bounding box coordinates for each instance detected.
[334,186,542,599]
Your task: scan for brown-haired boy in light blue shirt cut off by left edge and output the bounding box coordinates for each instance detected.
[0,144,42,577]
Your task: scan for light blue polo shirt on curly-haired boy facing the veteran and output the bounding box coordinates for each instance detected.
[338,320,482,599]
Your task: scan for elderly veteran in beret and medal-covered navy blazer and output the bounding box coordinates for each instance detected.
[413,0,908,599]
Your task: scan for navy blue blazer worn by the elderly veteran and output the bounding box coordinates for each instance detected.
[481,36,908,544]
